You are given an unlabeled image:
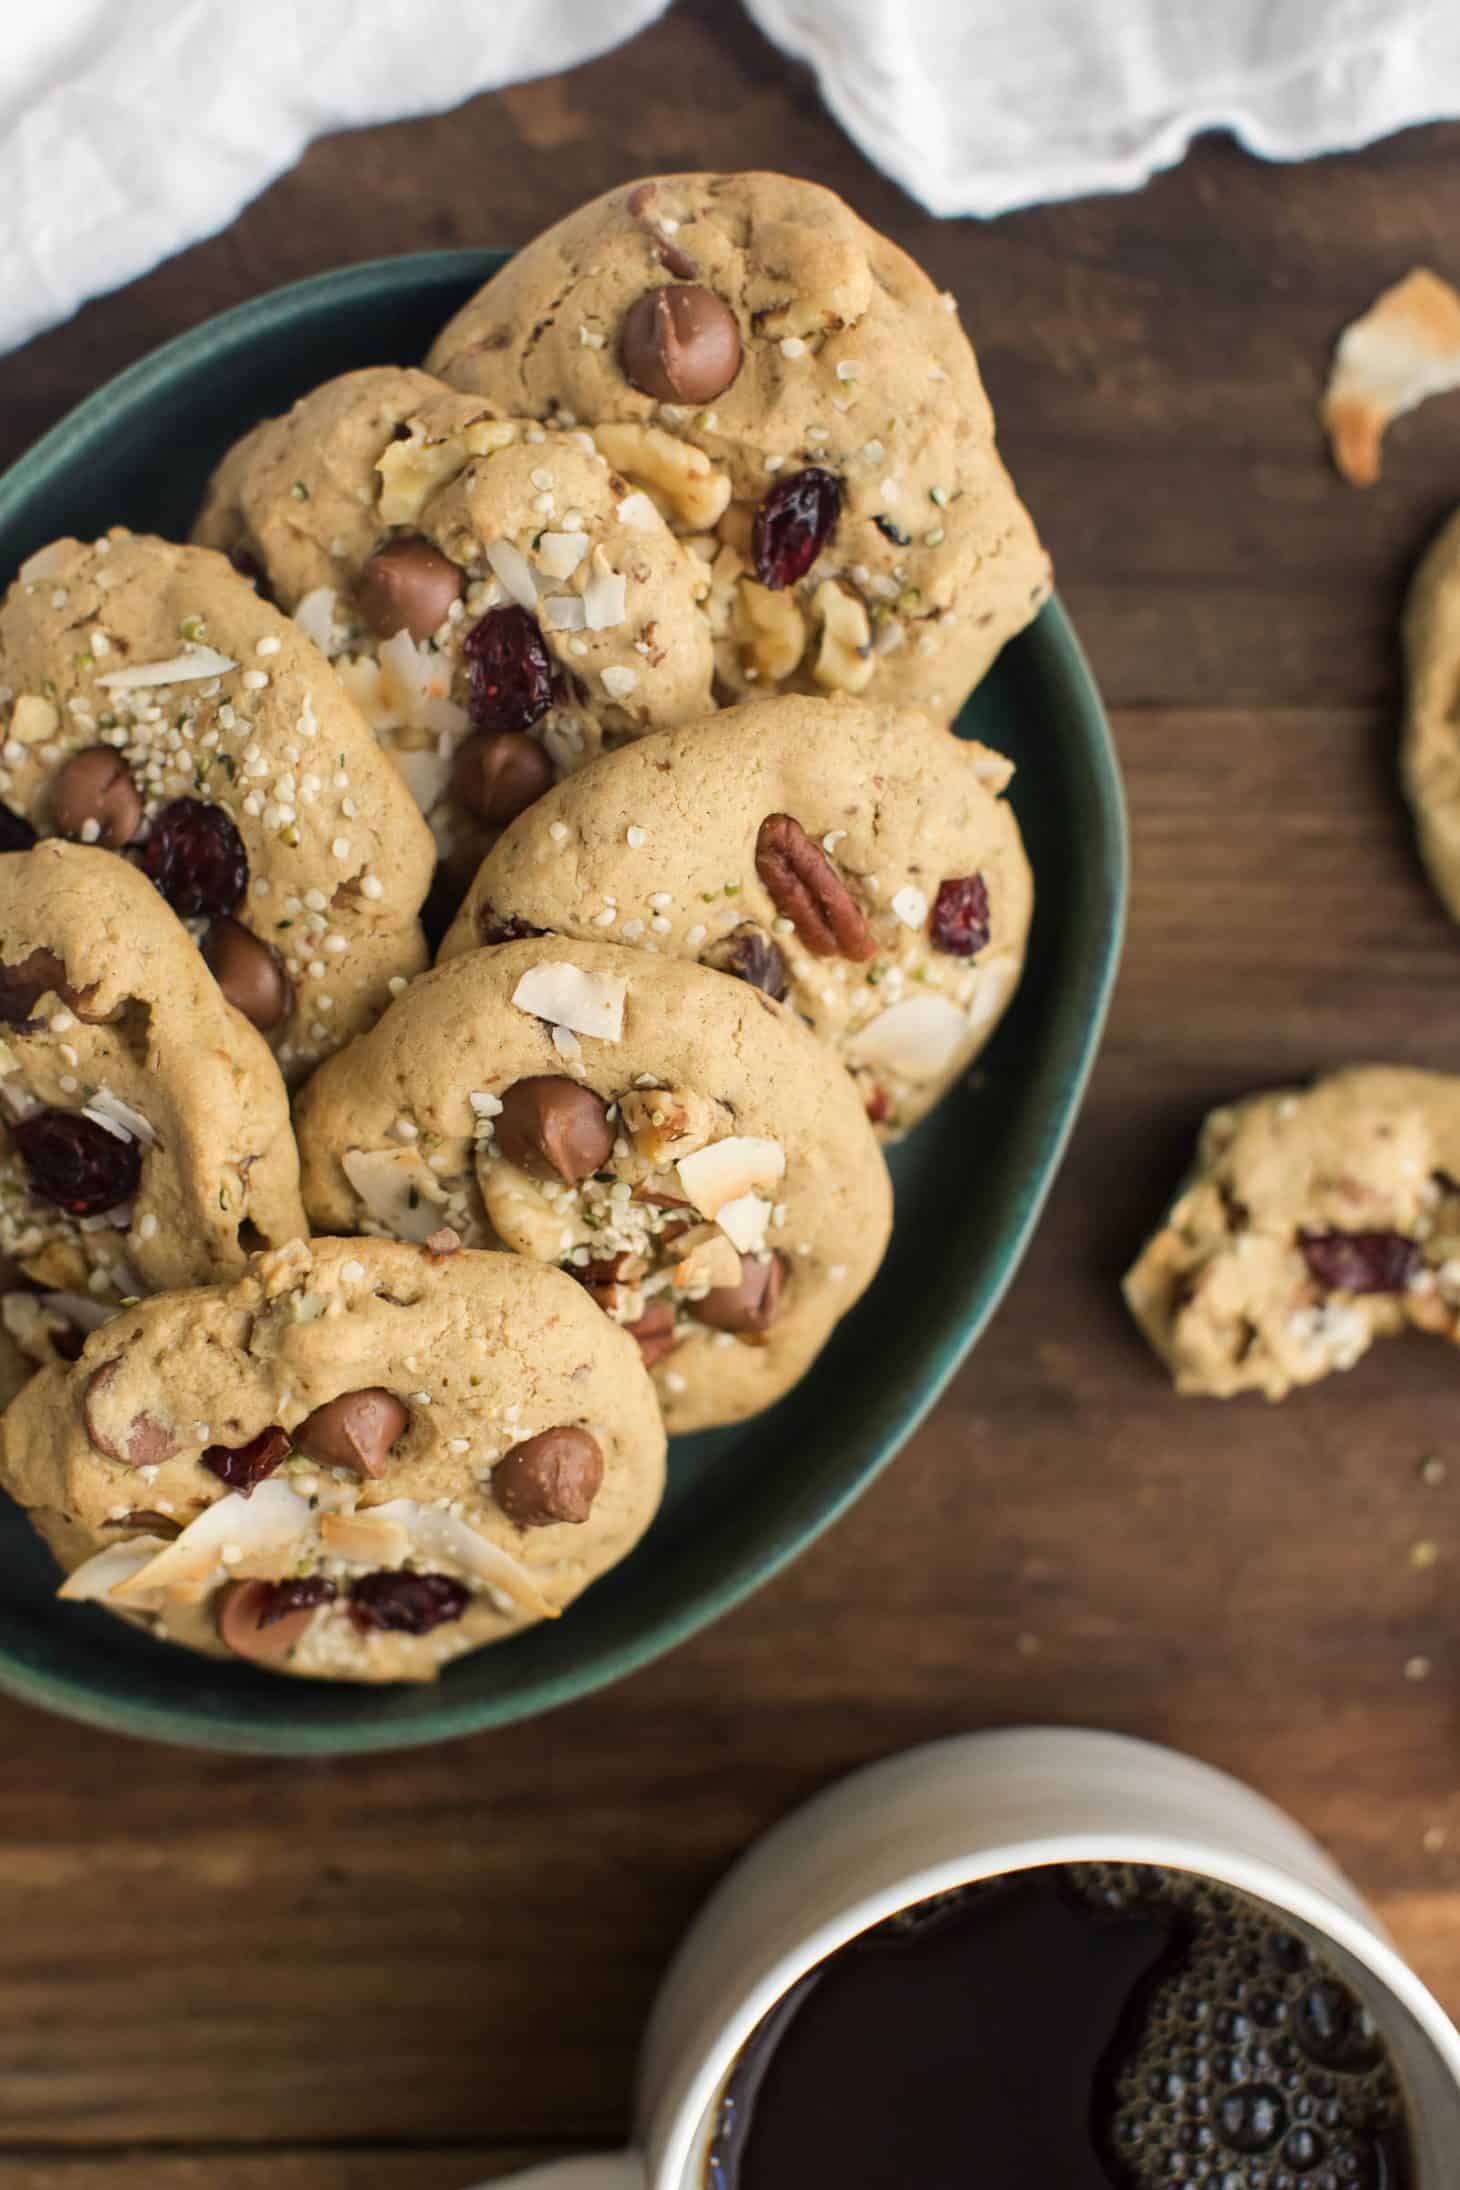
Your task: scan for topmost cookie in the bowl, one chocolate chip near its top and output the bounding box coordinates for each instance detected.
[427,175,1051,716]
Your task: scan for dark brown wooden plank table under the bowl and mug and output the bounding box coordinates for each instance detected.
[0,0,1460,2190]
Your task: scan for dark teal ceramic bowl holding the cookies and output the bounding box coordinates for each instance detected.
[0,252,1125,1756]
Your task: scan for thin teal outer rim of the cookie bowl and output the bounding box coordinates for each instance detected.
[0,245,1129,1756]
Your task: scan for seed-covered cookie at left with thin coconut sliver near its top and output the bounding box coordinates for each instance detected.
[0,532,433,1080]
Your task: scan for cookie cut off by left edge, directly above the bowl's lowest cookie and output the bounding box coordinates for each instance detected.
[0,841,306,1362]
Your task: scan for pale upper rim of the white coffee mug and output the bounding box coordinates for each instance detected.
[661,1833,1460,2190]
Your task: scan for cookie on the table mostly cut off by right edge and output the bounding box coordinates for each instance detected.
[1401,510,1460,920]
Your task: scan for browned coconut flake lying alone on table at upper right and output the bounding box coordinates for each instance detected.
[1322,267,1460,486]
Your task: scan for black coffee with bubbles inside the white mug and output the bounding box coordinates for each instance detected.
[707,1864,1414,2190]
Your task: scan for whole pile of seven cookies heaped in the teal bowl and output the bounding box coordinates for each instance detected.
[0,175,1048,1680]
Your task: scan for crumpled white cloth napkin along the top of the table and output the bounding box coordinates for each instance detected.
[0,0,1460,348]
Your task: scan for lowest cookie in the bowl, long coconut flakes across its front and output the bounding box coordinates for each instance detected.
[0,1240,663,1682]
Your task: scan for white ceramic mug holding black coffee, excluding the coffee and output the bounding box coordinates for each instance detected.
[488,1728,1460,2190]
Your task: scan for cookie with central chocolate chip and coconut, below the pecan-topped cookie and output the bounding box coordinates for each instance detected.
[296,937,891,1432]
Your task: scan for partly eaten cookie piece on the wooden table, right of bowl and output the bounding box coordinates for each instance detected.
[1125,1064,1460,1399]
